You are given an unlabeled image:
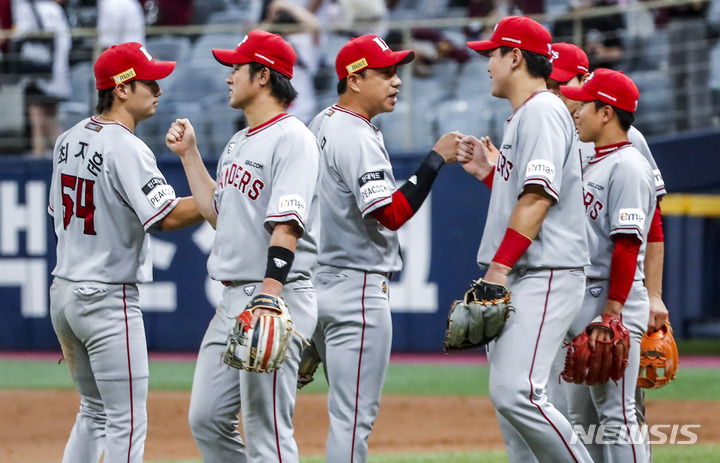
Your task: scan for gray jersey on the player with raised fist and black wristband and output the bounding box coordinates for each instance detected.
[208,114,318,281]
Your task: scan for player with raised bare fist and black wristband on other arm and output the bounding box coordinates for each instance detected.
[166,30,319,463]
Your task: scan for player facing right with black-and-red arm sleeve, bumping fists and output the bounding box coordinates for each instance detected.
[310,35,460,463]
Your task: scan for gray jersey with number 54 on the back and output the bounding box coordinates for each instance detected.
[48,117,177,283]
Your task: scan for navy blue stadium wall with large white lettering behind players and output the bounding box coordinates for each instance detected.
[0,133,720,352]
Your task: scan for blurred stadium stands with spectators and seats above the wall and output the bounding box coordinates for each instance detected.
[0,0,720,160]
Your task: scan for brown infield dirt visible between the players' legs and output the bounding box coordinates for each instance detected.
[0,390,720,463]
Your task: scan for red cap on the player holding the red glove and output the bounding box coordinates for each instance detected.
[560,68,640,113]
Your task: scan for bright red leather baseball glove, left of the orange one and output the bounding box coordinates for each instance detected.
[560,314,630,386]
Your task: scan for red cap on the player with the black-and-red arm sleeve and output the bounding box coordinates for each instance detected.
[335,35,415,80]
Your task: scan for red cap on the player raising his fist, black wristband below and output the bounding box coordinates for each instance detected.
[213,31,297,79]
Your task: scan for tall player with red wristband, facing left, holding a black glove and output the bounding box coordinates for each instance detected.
[458,16,591,462]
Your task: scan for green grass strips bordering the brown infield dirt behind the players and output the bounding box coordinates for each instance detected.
[5,358,720,463]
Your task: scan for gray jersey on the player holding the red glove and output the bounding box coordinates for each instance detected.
[583,144,655,280]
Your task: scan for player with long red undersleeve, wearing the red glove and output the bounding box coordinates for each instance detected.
[560,68,656,462]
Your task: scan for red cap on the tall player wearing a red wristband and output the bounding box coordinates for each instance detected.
[467,16,552,57]
